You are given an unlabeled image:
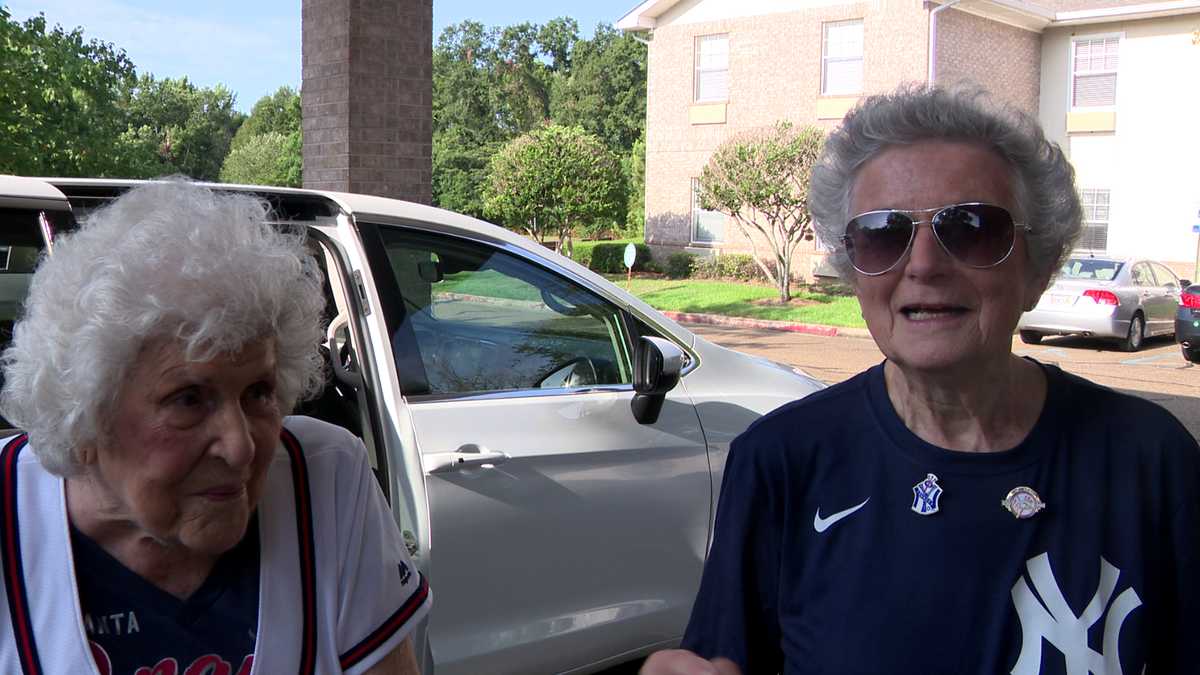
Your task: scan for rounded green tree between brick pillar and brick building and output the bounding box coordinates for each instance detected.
[484,125,625,250]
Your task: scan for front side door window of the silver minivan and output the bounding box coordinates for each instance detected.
[382,228,632,395]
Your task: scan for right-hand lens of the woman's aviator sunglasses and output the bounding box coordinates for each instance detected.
[934,204,1013,268]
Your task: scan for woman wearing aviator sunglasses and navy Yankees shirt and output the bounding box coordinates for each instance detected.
[642,86,1200,675]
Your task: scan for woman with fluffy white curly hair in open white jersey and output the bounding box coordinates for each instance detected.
[0,181,430,675]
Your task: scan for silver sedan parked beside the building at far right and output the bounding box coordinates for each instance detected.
[1016,255,1189,352]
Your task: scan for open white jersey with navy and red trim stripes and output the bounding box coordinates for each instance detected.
[0,417,431,675]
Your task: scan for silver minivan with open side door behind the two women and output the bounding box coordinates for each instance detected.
[0,177,821,675]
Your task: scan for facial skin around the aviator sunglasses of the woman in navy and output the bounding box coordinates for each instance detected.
[850,141,1045,374]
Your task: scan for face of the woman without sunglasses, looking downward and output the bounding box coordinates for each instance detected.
[89,340,282,555]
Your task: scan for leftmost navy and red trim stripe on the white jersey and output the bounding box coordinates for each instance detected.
[0,434,42,675]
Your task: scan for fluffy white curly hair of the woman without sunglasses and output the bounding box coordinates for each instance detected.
[0,180,325,476]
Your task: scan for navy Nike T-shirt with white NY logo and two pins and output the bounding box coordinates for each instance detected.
[683,365,1200,675]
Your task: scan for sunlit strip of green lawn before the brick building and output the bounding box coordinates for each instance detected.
[608,276,866,328]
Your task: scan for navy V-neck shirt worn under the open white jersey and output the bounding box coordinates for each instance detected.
[71,516,259,675]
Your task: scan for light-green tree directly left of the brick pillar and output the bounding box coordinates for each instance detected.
[220,86,304,187]
